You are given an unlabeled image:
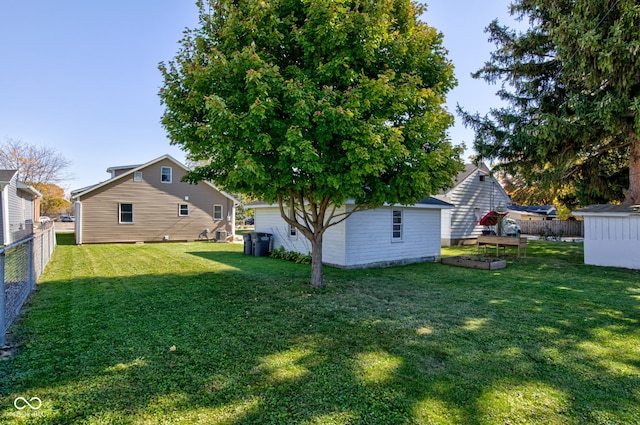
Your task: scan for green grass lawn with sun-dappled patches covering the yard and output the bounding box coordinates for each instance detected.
[0,237,640,425]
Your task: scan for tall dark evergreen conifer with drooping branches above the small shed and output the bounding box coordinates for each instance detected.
[463,0,640,204]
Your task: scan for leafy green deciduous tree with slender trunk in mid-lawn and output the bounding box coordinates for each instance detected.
[160,0,460,287]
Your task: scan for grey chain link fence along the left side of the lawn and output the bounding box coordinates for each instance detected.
[0,223,56,347]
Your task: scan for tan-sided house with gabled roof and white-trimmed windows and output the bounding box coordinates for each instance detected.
[72,155,238,244]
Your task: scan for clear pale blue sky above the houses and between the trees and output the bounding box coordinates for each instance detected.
[0,0,513,189]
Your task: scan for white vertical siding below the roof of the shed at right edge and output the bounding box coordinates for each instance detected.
[584,216,640,269]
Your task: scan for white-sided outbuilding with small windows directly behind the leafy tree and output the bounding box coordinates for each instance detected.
[246,198,453,269]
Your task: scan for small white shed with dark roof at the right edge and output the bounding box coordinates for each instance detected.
[573,205,640,269]
